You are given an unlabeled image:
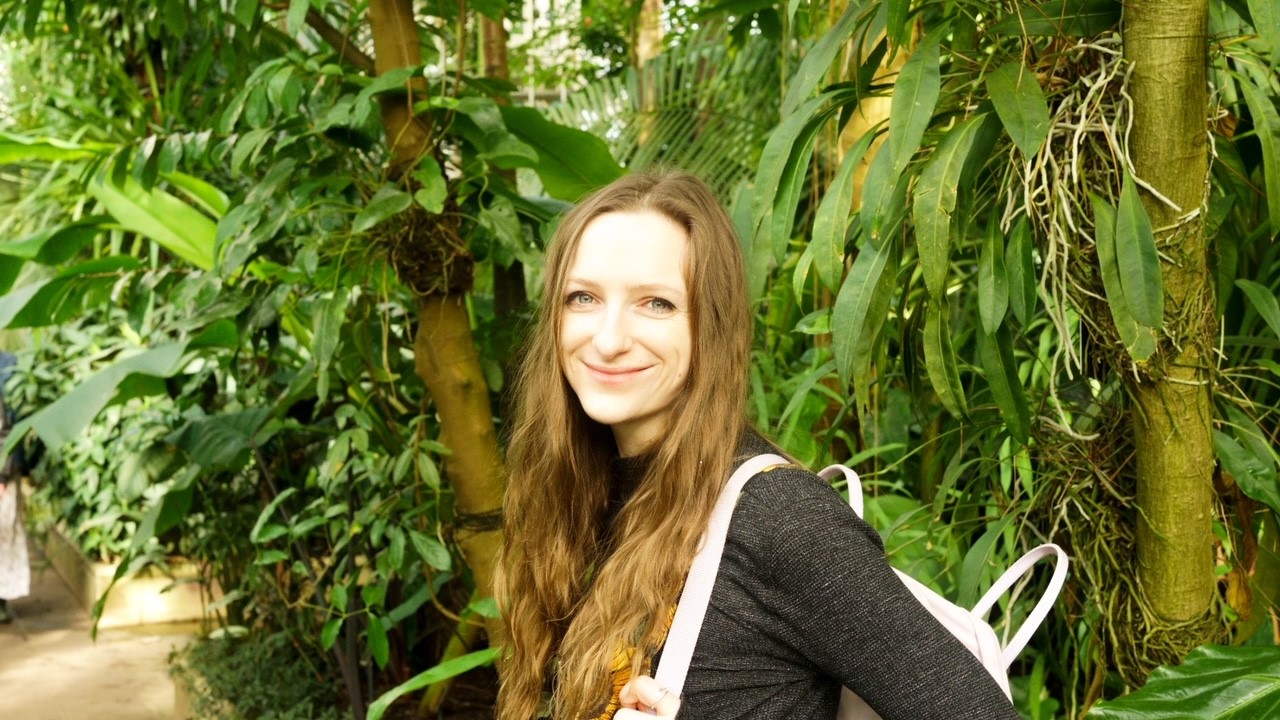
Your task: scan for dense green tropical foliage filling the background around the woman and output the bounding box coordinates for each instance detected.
[0,0,1280,719]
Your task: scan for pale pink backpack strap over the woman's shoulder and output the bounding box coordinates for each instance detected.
[654,455,787,696]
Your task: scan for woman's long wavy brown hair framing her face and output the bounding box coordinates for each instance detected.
[497,172,751,720]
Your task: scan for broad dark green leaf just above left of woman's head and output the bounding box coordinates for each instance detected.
[500,108,626,202]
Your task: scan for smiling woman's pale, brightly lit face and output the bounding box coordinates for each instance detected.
[559,210,692,457]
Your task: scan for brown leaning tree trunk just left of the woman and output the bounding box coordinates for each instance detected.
[369,0,503,622]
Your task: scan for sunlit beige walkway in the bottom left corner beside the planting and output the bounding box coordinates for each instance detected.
[0,545,196,720]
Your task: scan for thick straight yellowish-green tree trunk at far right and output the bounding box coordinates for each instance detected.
[1124,0,1217,622]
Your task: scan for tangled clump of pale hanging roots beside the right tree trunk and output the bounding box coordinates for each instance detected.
[1001,36,1217,691]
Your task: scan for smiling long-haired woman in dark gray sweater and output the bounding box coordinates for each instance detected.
[495,173,1018,720]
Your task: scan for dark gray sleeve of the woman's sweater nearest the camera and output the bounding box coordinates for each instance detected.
[730,468,1018,720]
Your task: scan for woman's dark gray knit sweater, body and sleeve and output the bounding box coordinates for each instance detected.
[609,433,1019,720]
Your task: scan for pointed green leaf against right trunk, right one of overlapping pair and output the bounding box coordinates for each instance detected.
[1115,173,1165,328]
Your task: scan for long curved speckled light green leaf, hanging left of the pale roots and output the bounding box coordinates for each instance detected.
[911,115,983,297]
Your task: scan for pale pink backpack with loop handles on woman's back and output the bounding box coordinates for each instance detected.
[654,455,1069,720]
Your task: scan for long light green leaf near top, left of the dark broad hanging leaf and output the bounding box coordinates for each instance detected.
[887,24,948,177]
